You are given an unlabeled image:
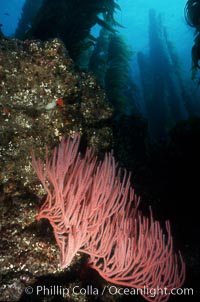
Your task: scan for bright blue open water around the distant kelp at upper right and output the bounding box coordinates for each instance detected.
[116,0,200,120]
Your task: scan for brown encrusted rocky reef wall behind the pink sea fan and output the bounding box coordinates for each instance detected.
[0,38,113,301]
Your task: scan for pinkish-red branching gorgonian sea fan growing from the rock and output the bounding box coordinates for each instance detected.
[32,134,185,301]
